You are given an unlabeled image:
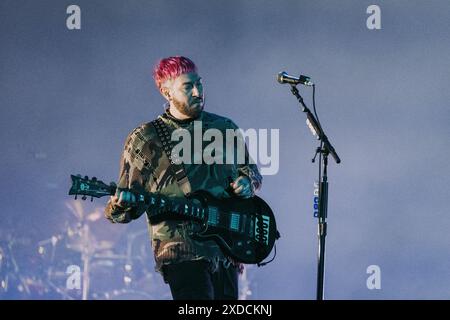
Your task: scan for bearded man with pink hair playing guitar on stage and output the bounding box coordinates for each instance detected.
[105,56,262,300]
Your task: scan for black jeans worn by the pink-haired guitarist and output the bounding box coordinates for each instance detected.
[163,260,238,300]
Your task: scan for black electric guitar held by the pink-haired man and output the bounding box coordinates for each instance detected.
[69,175,280,264]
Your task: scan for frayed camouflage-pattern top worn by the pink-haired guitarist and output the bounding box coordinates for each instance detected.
[105,111,262,272]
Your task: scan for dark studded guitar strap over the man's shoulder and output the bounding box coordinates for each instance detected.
[152,118,192,196]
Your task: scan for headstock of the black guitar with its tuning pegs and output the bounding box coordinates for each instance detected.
[69,174,117,201]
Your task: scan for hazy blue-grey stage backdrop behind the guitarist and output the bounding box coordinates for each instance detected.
[0,0,450,299]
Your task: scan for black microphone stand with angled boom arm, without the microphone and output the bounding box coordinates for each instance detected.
[291,84,341,300]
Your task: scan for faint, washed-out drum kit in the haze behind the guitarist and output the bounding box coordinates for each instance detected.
[0,201,171,300]
